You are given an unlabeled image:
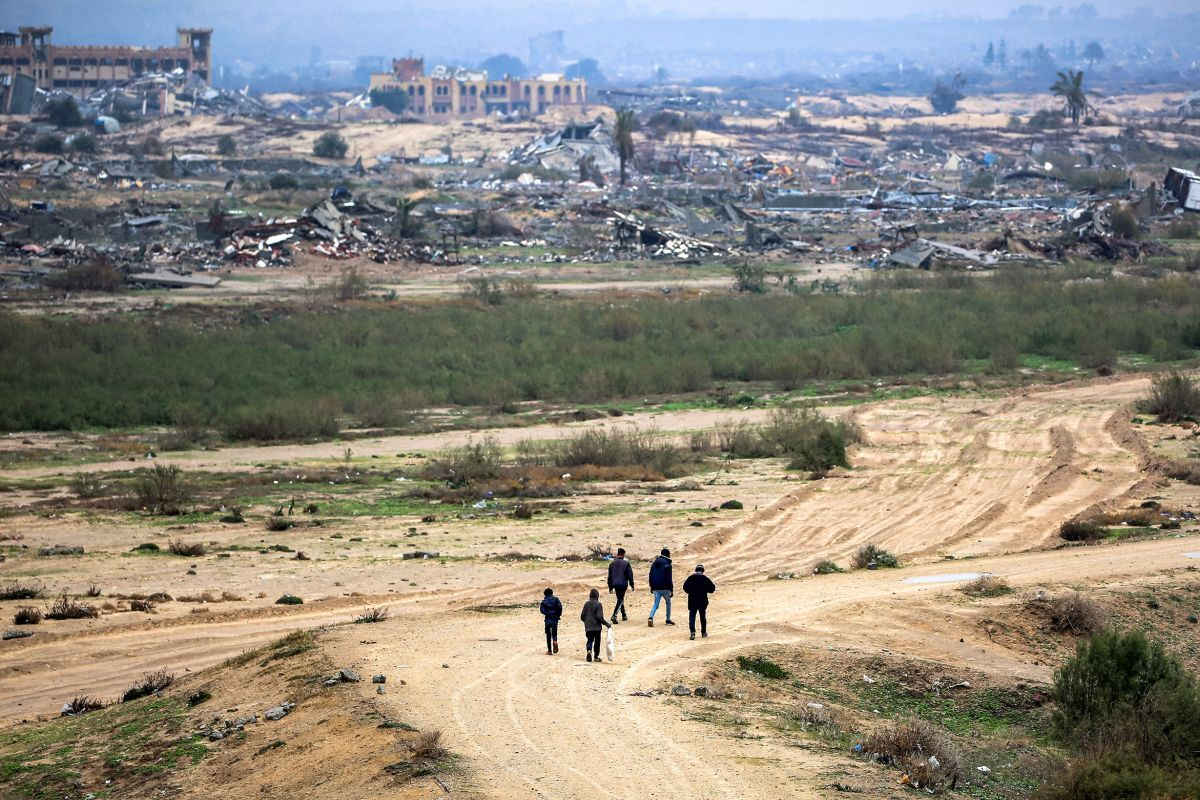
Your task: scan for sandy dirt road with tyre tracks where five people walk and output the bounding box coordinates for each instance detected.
[0,378,1180,799]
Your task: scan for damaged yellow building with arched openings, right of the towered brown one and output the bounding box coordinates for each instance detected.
[371,58,588,121]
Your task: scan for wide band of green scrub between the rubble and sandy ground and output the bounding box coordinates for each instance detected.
[0,270,1200,431]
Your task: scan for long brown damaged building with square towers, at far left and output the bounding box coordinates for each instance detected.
[0,25,212,113]
